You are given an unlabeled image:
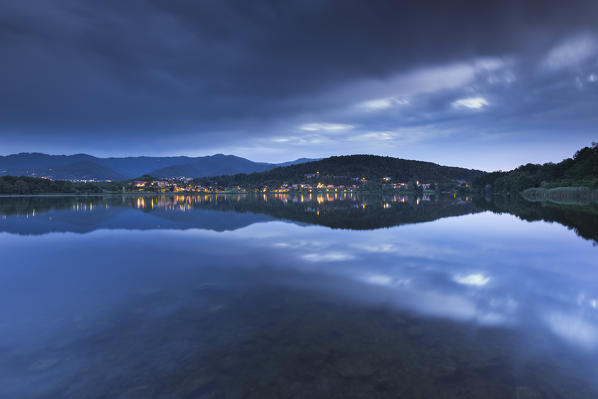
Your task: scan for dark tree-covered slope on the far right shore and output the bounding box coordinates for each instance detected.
[474,143,598,192]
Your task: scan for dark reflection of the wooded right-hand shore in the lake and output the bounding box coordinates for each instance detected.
[474,196,598,245]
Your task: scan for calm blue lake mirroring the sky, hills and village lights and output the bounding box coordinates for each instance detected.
[0,193,598,399]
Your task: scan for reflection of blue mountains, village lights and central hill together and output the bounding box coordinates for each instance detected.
[0,193,482,234]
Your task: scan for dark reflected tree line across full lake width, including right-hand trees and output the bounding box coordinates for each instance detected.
[0,193,598,243]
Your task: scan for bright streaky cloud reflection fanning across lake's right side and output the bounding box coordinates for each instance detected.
[232,214,598,348]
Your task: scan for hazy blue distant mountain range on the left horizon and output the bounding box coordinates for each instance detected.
[0,153,313,180]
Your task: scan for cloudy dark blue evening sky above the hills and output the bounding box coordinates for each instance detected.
[0,0,598,170]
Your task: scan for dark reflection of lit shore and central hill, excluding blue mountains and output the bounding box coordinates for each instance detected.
[0,194,481,230]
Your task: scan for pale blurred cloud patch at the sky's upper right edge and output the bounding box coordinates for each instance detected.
[542,34,598,70]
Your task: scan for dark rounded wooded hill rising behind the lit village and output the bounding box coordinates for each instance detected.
[197,155,484,185]
